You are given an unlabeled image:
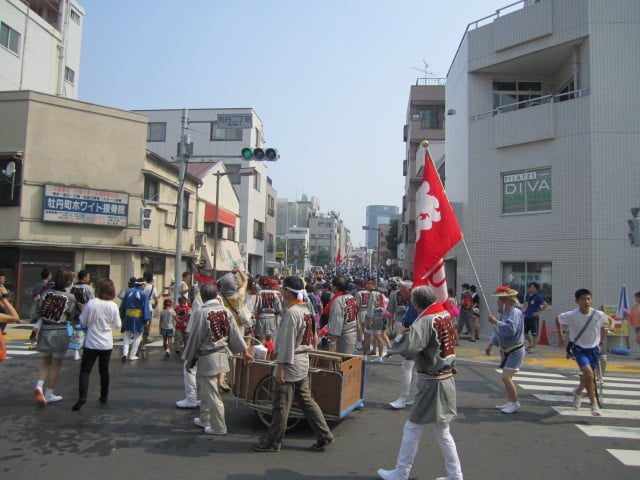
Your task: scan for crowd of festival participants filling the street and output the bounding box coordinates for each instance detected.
[10,268,640,480]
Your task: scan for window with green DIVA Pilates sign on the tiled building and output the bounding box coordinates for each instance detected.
[502,168,551,214]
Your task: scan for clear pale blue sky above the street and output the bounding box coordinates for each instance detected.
[78,0,512,246]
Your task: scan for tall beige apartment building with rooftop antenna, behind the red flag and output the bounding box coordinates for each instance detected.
[400,78,444,278]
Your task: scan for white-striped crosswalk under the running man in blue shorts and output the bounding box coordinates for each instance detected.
[498,370,640,467]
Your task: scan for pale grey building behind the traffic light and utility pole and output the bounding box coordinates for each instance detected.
[135,108,268,274]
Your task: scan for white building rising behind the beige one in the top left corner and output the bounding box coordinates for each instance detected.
[0,0,84,98]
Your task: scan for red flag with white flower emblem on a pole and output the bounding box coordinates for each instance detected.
[413,149,462,302]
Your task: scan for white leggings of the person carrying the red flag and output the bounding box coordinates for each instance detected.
[395,420,463,480]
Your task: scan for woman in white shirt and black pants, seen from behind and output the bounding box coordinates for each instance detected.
[71,278,122,410]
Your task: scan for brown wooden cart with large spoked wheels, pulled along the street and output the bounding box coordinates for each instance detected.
[232,350,366,428]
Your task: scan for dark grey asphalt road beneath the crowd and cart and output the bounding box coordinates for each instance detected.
[0,340,640,480]
